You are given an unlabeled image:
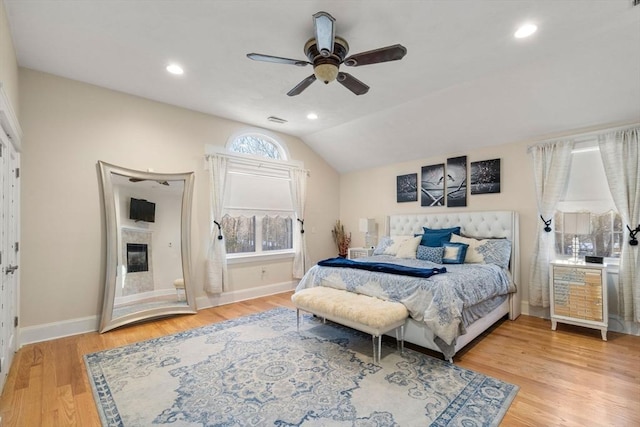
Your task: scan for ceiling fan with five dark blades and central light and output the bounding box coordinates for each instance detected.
[247,12,407,96]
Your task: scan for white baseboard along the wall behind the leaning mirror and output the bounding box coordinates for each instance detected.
[18,281,298,347]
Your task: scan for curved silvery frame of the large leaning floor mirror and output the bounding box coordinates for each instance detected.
[98,161,196,333]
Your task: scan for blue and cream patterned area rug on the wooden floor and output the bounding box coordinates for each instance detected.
[85,308,518,427]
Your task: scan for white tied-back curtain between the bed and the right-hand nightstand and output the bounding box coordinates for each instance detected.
[529,141,574,307]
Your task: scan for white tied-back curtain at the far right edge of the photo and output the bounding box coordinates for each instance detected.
[599,128,640,322]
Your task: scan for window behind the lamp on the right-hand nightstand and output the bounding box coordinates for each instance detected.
[554,141,624,258]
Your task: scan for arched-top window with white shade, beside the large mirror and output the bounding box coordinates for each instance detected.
[216,132,295,258]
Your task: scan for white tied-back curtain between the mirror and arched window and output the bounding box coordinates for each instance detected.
[204,155,229,294]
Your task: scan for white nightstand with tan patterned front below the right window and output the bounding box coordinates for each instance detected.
[549,261,609,341]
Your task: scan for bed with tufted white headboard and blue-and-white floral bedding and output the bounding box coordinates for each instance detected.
[296,211,520,360]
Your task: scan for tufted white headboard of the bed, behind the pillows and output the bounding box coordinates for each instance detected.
[386,211,520,318]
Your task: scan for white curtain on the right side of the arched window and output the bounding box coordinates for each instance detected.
[290,169,309,279]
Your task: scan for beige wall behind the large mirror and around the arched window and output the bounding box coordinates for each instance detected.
[19,68,339,327]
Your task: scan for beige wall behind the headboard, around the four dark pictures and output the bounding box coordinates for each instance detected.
[340,142,538,310]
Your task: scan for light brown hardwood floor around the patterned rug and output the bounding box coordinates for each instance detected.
[0,293,640,427]
